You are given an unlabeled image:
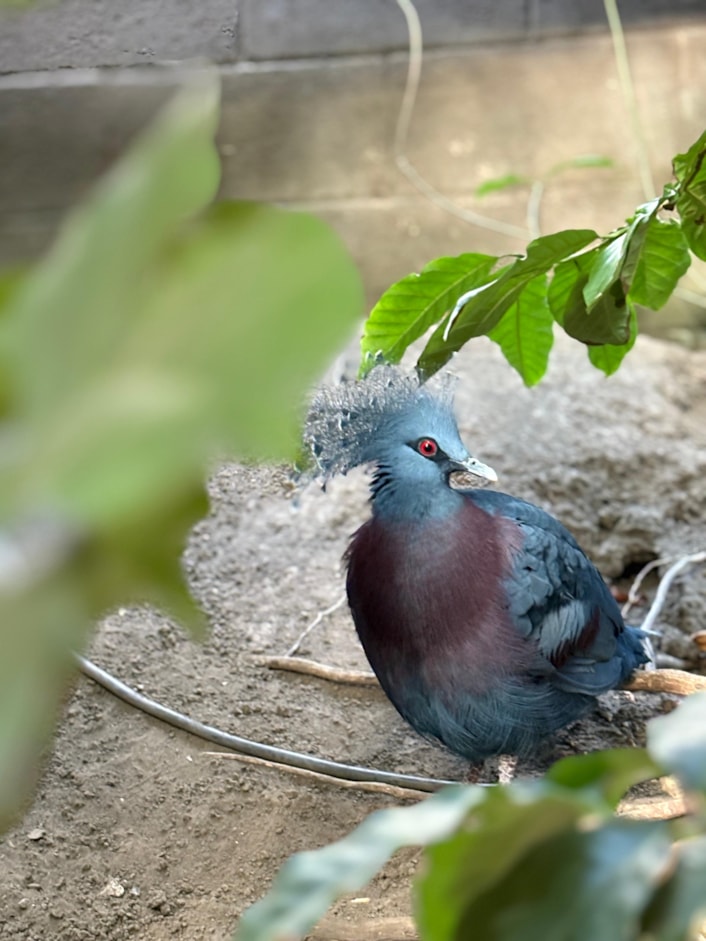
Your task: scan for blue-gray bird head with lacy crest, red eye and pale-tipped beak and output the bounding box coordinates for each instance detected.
[304,366,497,516]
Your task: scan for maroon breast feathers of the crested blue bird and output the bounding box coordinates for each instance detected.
[340,501,531,689]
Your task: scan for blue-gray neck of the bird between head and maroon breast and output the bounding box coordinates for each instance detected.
[370,465,463,521]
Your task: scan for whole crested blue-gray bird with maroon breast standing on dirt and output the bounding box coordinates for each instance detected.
[307,368,649,762]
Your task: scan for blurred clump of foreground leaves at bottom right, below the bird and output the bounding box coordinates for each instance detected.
[235,694,706,941]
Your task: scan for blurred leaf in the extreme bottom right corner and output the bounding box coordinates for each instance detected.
[643,836,706,941]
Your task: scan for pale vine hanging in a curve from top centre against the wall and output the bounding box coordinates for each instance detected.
[394,0,527,242]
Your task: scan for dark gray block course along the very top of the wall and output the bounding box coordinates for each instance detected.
[0,0,706,73]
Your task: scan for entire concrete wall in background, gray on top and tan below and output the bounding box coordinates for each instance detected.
[0,0,706,342]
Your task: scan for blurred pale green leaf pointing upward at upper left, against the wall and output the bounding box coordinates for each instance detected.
[2,76,220,416]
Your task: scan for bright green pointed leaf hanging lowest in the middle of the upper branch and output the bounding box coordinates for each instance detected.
[488,274,554,386]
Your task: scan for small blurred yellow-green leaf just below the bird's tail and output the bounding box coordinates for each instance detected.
[546,748,662,807]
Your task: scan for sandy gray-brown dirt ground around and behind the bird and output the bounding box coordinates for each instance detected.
[0,340,706,941]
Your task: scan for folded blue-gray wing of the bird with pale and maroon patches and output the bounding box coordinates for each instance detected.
[472,491,641,695]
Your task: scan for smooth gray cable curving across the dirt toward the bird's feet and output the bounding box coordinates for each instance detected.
[75,654,456,792]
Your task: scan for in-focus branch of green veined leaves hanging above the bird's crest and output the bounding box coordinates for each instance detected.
[360,132,706,386]
